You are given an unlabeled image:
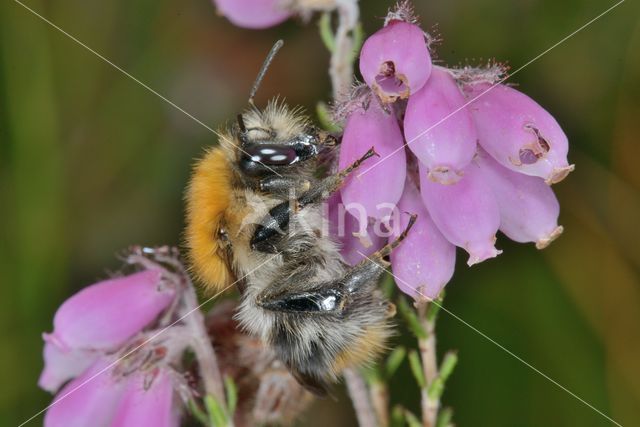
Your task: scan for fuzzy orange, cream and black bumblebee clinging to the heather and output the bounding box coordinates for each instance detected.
[185,45,415,395]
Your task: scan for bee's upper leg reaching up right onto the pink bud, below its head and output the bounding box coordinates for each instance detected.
[251,148,377,253]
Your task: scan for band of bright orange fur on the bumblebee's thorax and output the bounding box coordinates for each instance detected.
[186,147,233,291]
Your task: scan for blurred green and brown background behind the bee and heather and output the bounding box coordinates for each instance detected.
[0,0,640,427]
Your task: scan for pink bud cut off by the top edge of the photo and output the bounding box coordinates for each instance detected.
[213,0,291,29]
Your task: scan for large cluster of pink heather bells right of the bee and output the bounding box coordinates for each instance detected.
[334,3,573,299]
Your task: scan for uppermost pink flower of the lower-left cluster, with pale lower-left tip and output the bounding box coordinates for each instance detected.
[39,269,176,391]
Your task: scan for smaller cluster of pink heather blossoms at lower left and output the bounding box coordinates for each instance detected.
[39,251,189,427]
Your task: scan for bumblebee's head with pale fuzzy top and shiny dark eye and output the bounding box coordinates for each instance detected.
[237,101,336,177]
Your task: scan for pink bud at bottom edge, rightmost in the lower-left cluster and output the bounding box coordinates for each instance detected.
[111,368,180,427]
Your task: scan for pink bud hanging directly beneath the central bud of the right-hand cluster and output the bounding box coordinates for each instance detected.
[420,162,502,266]
